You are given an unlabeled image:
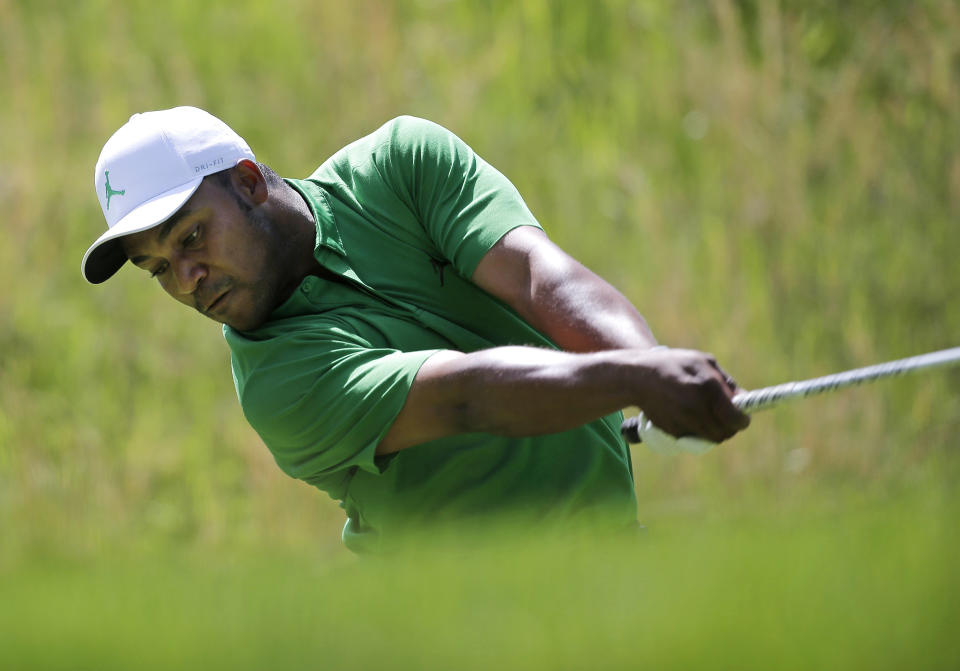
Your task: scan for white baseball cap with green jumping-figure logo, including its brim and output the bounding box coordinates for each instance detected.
[81,107,256,284]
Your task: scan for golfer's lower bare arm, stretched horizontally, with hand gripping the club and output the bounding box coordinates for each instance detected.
[377,347,750,454]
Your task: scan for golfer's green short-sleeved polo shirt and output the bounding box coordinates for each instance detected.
[224,117,636,552]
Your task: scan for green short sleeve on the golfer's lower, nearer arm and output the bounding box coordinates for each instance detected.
[234,330,436,488]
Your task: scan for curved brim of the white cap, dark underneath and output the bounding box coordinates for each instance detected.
[80,177,203,284]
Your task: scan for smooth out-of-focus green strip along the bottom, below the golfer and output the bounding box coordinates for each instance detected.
[0,498,960,670]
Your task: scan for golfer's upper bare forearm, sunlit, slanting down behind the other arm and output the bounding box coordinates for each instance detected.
[472,226,657,352]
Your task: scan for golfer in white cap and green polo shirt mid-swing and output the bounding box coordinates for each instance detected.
[82,107,749,552]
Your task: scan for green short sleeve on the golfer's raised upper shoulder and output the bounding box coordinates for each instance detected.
[378,116,540,278]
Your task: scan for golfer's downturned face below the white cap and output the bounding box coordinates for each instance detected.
[122,173,284,331]
